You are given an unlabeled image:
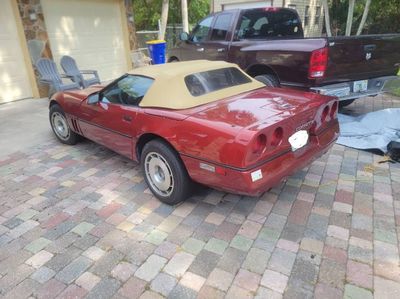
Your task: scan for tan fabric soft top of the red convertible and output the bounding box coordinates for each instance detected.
[129,60,264,109]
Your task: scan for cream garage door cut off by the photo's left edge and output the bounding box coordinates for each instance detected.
[0,0,32,103]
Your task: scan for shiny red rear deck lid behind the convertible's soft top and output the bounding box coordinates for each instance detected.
[191,88,332,128]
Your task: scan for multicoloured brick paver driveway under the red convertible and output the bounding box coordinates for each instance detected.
[0,98,400,299]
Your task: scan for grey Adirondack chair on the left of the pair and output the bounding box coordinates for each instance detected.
[36,58,80,97]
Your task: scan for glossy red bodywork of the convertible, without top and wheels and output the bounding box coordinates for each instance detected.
[53,86,339,195]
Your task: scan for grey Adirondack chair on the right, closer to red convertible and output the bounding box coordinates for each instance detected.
[60,56,100,88]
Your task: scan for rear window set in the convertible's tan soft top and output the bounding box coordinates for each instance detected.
[185,67,251,97]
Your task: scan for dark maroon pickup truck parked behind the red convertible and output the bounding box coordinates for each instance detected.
[168,7,400,107]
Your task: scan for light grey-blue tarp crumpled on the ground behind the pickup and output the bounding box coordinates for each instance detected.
[337,108,400,153]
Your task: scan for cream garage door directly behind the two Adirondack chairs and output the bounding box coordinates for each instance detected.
[42,0,127,81]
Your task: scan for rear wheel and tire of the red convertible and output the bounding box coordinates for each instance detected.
[140,139,192,205]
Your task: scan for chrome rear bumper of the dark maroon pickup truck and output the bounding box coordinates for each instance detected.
[311,76,399,101]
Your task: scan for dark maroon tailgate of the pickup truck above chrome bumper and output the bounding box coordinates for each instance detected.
[317,34,400,85]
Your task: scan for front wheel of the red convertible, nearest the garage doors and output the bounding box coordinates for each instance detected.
[49,104,79,145]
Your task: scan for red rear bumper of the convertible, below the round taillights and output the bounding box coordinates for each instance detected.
[181,123,339,196]
